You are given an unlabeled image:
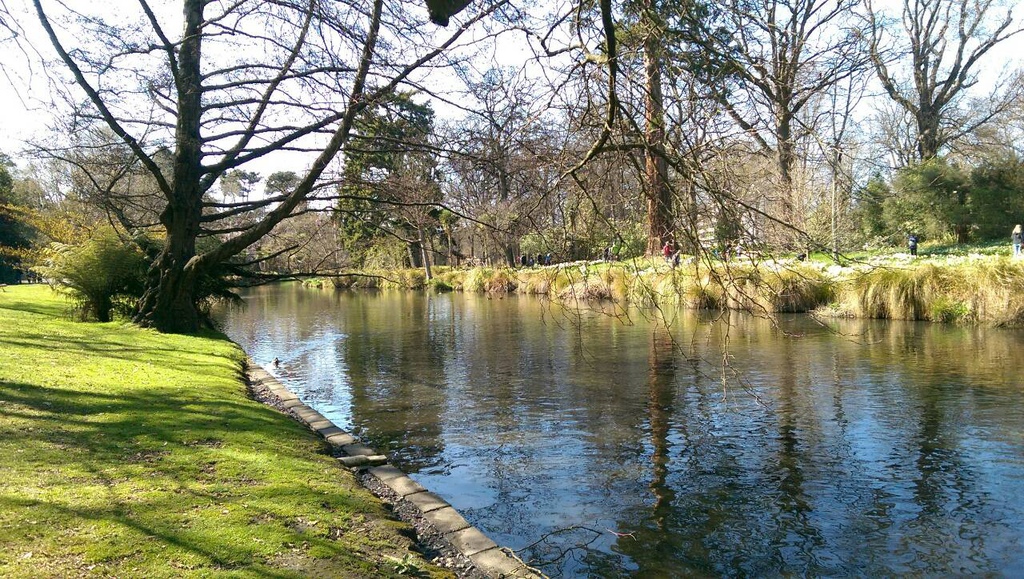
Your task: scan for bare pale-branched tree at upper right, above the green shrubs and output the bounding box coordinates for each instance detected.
[866,0,1021,161]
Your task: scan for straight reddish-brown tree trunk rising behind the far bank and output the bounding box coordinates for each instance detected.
[641,0,672,255]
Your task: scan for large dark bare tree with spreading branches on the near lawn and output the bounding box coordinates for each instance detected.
[22,0,504,333]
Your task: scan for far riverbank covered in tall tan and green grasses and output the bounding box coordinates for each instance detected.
[306,253,1024,327]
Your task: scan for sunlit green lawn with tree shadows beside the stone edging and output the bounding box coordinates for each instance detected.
[0,286,447,577]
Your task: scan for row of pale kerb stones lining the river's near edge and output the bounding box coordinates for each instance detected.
[246,360,545,579]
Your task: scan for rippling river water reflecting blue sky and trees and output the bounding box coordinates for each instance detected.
[221,287,1024,577]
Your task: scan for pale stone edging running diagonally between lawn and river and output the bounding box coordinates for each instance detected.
[246,360,545,579]
